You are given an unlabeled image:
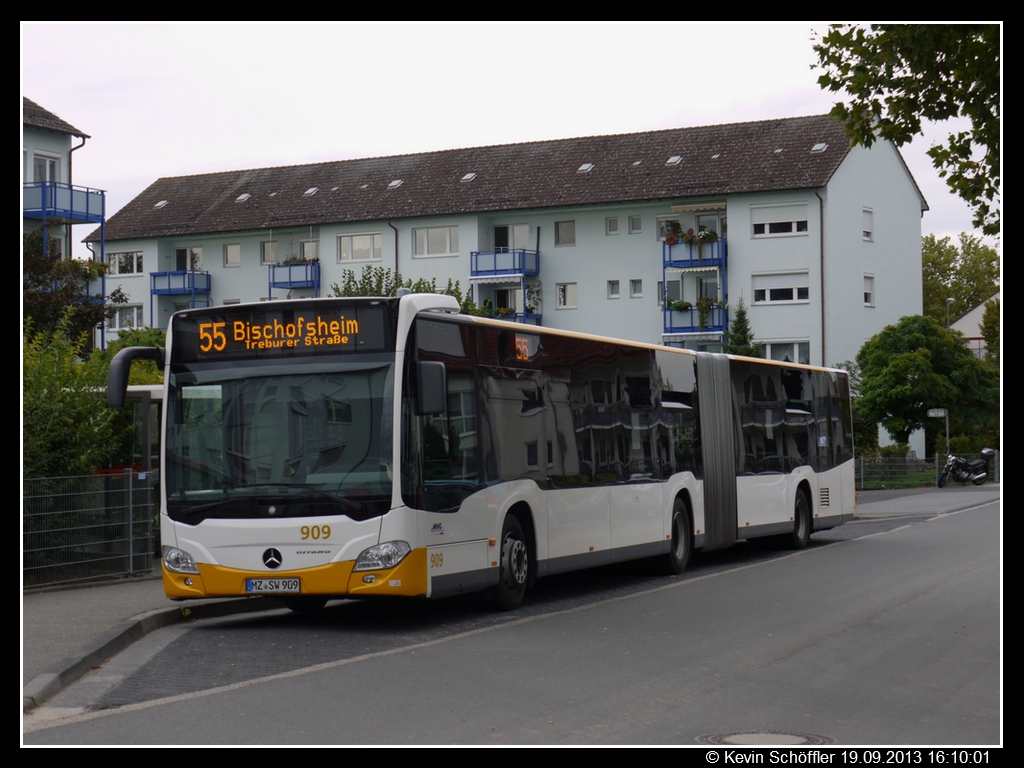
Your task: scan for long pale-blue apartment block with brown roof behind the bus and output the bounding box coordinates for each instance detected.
[89,116,927,365]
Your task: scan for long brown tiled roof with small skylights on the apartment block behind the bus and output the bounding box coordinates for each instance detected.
[94,116,849,241]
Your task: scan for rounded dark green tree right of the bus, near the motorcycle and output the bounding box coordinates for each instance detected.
[857,315,999,445]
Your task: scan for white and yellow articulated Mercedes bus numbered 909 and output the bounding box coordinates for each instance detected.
[109,294,855,610]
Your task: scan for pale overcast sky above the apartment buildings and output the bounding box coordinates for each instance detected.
[22,23,1001,255]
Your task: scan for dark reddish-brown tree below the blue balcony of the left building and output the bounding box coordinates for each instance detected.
[22,223,128,342]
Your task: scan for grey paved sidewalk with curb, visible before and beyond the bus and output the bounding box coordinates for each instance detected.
[22,485,999,709]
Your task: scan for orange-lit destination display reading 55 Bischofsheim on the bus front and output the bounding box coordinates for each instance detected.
[172,300,394,362]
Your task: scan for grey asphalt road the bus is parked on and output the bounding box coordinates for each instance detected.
[25,503,1001,745]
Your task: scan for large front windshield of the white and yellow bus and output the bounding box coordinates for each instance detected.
[165,354,394,524]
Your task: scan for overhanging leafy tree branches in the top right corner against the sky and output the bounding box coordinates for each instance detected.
[814,25,1000,234]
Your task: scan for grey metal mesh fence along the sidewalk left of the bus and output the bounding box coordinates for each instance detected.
[22,471,159,587]
